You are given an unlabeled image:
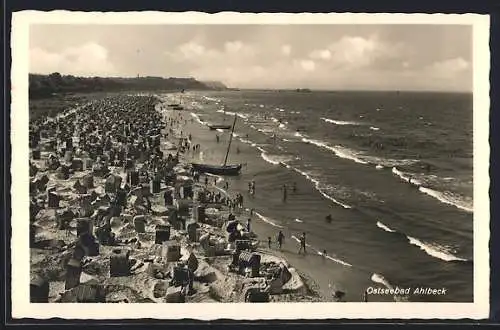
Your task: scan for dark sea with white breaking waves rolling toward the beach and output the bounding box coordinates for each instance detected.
[162,91,473,302]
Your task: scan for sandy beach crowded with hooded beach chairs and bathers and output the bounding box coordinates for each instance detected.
[30,95,321,303]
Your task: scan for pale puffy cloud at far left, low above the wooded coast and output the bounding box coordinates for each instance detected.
[30,42,115,76]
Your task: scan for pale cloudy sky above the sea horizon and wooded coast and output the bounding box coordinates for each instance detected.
[30,25,472,91]
